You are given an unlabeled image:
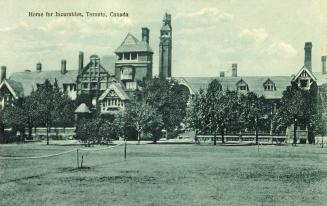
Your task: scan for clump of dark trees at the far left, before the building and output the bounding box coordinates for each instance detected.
[0,80,75,144]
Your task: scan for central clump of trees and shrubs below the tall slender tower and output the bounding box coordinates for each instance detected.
[76,78,189,143]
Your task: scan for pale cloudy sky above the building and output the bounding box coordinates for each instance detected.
[0,0,327,77]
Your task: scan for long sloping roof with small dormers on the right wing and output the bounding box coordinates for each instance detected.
[177,76,292,99]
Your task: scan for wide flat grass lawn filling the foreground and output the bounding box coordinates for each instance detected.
[0,144,327,206]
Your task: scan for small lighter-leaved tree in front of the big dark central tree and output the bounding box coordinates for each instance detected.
[126,101,162,143]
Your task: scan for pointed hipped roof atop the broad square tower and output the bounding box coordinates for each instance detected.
[115,33,153,53]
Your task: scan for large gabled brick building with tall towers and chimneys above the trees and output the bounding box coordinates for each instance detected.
[0,13,327,142]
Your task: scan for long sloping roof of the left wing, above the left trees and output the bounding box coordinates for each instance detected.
[8,69,78,96]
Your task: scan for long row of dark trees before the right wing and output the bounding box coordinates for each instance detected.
[186,80,327,144]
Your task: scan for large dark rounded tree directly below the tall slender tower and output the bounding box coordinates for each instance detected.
[143,78,189,138]
